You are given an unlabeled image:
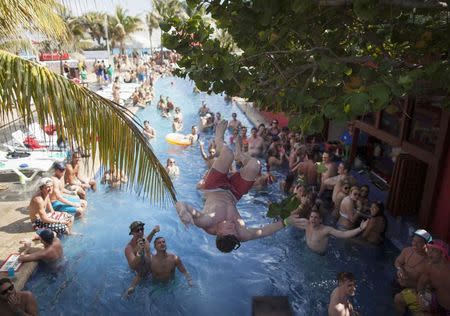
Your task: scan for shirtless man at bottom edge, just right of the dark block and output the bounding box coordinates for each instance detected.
[328,272,358,316]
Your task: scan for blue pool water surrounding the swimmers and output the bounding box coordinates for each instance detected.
[27,78,396,316]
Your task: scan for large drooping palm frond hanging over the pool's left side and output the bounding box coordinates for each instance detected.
[0,50,176,204]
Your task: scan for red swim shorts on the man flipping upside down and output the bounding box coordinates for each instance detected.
[205,168,255,201]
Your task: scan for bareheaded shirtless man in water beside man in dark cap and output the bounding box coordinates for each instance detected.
[151,237,192,286]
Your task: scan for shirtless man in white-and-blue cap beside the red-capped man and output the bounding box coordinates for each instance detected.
[394,229,433,313]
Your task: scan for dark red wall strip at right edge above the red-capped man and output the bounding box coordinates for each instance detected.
[432,148,450,242]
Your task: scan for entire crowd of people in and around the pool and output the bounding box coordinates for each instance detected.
[0,48,450,316]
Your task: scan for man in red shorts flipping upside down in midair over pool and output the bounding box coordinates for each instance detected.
[176,120,299,252]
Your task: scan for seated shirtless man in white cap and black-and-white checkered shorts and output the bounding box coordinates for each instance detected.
[28,178,73,236]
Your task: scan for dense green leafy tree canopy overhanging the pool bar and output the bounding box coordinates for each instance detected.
[160,0,450,131]
